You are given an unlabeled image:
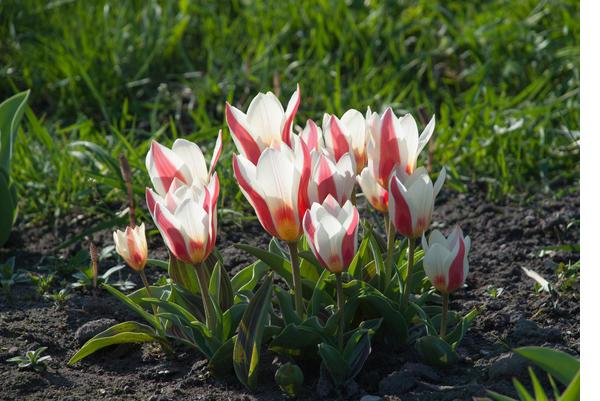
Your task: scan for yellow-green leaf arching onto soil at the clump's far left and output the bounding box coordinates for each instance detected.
[68,322,164,365]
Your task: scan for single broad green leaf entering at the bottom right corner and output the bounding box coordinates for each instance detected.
[514,347,579,386]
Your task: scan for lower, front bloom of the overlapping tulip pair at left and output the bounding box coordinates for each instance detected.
[146,173,219,264]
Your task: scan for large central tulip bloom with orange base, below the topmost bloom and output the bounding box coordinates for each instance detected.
[233,135,311,242]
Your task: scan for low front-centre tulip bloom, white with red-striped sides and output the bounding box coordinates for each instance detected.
[303,195,359,273]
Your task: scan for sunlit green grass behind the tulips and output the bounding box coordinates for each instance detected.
[0,0,579,230]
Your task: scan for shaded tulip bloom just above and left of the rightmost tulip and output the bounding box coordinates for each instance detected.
[389,167,446,238]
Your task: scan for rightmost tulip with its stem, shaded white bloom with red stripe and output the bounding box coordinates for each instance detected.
[421,226,471,337]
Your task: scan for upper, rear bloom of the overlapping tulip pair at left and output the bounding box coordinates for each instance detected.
[146,131,223,196]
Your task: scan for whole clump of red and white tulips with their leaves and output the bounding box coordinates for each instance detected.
[70,87,476,395]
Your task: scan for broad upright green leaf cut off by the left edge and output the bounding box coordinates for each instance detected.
[0,91,29,246]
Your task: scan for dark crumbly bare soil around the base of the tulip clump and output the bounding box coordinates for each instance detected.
[0,191,580,401]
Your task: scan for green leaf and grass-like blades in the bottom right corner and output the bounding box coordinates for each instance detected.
[479,347,580,401]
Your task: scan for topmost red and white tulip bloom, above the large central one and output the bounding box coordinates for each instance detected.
[225,85,300,164]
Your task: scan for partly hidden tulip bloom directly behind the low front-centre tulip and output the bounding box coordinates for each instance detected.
[308,150,355,204]
